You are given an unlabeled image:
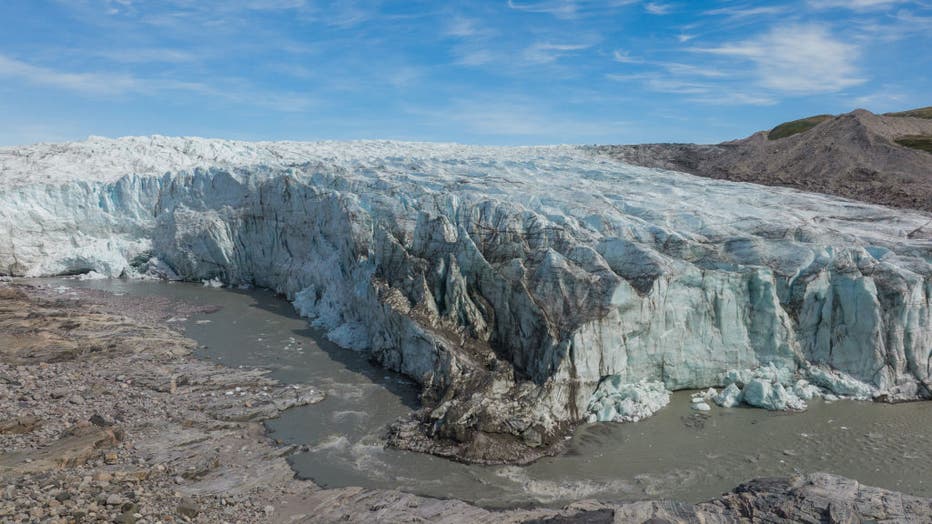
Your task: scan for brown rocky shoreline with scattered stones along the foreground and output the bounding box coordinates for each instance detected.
[0,282,932,523]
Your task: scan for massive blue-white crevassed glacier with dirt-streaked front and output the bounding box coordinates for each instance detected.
[0,136,932,462]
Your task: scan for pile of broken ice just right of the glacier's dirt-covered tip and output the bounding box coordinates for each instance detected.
[587,375,670,422]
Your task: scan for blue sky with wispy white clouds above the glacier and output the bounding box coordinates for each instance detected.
[0,0,932,145]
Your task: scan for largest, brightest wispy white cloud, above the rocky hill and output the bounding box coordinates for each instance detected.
[692,25,866,95]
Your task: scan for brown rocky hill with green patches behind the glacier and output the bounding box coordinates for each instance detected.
[595,108,932,211]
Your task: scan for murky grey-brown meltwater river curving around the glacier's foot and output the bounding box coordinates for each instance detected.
[45,280,932,507]
